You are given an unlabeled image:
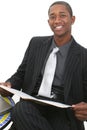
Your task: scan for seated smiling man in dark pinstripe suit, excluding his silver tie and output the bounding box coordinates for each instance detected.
[0,1,87,130]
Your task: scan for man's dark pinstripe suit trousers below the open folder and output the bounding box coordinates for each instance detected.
[10,100,70,130]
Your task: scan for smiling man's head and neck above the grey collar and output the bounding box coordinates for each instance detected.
[48,2,75,46]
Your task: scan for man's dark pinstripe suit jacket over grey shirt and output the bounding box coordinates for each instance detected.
[9,36,87,130]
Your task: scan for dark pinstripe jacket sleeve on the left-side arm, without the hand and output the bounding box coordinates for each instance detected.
[6,39,32,90]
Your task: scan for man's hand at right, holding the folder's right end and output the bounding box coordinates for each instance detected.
[72,102,87,121]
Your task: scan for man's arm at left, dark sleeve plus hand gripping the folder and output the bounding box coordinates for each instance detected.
[0,37,33,96]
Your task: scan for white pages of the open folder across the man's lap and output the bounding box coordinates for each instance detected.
[0,85,71,108]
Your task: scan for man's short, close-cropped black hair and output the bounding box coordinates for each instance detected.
[48,1,73,16]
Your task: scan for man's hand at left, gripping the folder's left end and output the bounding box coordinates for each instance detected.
[0,82,12,96]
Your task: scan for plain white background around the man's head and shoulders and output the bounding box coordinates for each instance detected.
[0,0,87,129]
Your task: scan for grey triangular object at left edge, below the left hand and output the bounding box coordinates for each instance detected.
[0,96,12,115]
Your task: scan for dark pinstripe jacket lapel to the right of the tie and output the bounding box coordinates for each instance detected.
[63,40,80,101]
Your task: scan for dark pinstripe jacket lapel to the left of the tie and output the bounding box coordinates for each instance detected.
[34,37,52,85]
